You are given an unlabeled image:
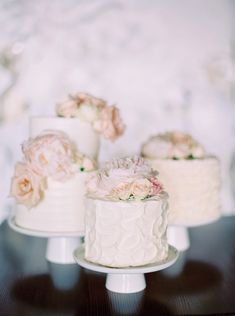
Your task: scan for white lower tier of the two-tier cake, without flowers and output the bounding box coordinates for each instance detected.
[15,173,87,233]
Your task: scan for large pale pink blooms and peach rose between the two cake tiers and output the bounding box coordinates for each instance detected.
[11,131,96,208]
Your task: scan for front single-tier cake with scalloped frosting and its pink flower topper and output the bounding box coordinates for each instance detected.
[85,158,168,267]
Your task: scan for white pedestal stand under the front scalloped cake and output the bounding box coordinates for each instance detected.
[74,245,179,293]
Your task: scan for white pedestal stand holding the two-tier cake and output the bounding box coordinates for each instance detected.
[8,216,84,264]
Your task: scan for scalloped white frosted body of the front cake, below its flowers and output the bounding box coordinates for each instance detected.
[85,199,168,267]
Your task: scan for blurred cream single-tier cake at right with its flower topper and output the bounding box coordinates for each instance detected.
[141,132,221,226]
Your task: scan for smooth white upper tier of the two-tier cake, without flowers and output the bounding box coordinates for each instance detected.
[29,117,100,159]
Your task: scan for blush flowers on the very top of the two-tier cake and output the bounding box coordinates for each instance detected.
[56,93,125,141]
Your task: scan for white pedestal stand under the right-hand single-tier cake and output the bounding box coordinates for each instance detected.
[167,216,220,251]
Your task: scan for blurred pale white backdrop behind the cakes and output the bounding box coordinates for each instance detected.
[0,0,235,221]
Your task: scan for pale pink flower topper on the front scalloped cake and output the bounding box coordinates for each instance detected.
[87,157,163,201]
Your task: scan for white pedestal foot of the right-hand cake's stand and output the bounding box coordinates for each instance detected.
[167,226,190,251]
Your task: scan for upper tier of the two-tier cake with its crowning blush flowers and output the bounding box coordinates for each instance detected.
[30,93,124,159]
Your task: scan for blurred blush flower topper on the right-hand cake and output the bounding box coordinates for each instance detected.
[141,131,205,160]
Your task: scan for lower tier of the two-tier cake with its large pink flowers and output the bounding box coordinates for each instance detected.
[11,131,95,232]
